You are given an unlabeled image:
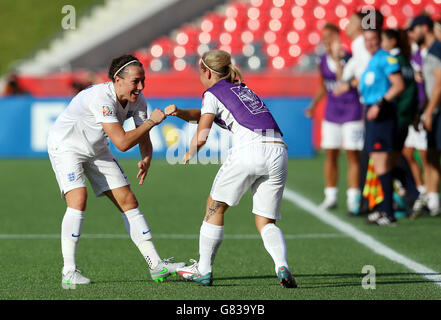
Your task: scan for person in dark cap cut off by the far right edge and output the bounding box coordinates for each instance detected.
[410,15,441,217]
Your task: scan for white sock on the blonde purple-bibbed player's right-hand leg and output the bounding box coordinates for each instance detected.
[260,223,289,273]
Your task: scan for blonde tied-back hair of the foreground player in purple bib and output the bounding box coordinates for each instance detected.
[200,50,242,83]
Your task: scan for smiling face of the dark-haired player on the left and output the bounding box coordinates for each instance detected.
[115,66,145,106]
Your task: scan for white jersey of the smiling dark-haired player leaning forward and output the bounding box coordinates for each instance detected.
[48,82,147,156]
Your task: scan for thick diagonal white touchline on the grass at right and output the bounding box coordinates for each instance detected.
[283,188,441,286]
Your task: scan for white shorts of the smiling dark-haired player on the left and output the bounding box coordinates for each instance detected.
[48,149,130,198]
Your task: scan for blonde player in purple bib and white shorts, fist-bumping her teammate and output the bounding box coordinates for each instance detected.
[165,50,297,288]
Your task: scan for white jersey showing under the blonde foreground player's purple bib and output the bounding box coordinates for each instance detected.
[201,91,283,147]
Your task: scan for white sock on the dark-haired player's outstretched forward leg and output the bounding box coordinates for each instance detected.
[121,208,161,269]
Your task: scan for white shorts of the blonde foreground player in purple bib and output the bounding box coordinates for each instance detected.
[210,143,288,220]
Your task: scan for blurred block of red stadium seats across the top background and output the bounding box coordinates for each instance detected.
[22,0,441,87]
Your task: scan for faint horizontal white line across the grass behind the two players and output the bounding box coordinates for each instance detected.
[0,233,346,240]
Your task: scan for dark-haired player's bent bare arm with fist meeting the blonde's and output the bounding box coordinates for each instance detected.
[101,109,165,152]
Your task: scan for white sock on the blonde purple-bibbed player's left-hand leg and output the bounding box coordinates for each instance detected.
[198,221,224,274]
